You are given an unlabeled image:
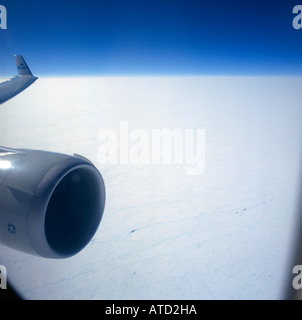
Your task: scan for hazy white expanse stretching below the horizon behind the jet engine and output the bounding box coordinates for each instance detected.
[0,77,302,299]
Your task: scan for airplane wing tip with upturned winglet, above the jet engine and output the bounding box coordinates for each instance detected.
[0,55,38,104]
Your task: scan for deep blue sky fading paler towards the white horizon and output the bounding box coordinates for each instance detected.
[0,0,302,76]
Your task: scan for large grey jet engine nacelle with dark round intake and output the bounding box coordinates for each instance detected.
[0,148,105,258]
